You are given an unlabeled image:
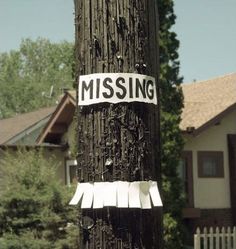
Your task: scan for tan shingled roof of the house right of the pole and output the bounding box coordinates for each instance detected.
[180,73,236,132]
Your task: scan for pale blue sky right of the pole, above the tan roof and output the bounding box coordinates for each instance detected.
[174,0,236,82]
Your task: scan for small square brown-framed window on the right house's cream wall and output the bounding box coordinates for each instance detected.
[198,151,224,178]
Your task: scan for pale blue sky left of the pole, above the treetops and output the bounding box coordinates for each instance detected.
[0,0,74,52]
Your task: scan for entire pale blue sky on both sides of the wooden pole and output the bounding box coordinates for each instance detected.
[0,0,236,82]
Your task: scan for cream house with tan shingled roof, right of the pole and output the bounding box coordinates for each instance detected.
[180,73,236,229]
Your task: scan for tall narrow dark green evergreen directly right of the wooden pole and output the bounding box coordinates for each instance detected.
[158,0,184,249]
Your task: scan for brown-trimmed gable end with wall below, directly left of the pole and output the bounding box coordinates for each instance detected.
[36,91,77,185]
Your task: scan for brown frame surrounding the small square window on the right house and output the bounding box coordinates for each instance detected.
[197,151,224,178]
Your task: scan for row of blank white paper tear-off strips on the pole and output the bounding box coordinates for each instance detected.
[69,181,162,209]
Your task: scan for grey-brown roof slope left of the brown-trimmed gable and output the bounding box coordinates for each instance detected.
[0,106,55,144]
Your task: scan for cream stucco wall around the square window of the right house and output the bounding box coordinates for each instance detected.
[184,111,236,209]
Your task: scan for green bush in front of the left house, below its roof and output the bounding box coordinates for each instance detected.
[0,151,79,249]
